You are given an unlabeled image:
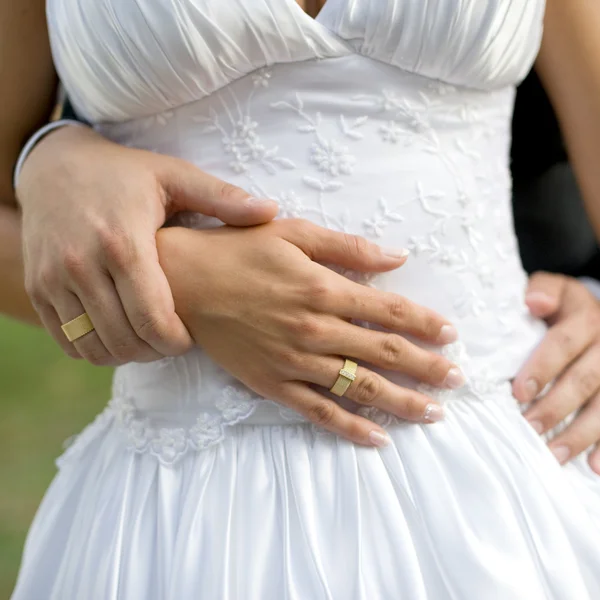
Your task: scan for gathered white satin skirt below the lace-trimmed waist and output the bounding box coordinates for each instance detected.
[13,390,600,600]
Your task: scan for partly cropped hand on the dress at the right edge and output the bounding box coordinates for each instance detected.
[513,273,600,474]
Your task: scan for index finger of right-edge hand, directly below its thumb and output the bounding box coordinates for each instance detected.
[513,312,595,403]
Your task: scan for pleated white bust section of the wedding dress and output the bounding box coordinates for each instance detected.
[48,0,544,122]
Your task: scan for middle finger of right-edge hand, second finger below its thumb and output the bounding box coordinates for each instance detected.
[525,344,600,433]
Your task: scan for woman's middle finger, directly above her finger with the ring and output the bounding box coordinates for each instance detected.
[319,324,465,389]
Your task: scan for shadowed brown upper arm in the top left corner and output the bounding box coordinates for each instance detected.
[0,0,57,205]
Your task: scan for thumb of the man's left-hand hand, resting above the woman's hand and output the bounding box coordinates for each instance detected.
[157,156,279,227]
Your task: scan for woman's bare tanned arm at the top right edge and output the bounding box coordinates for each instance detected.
[536,0,600,239]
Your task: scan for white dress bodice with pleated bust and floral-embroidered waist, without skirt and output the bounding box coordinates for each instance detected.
[48,0,544,462]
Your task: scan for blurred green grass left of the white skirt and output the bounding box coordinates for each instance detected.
[0,317,112,599]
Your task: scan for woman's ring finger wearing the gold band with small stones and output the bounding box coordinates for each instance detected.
[305,357,444,423]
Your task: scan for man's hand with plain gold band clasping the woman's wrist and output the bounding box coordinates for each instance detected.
[17,127,277,365]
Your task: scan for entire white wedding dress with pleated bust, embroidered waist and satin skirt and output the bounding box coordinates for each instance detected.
[13,0,600,600]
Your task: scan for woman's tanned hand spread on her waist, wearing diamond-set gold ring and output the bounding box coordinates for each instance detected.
[157,220,464,446]
